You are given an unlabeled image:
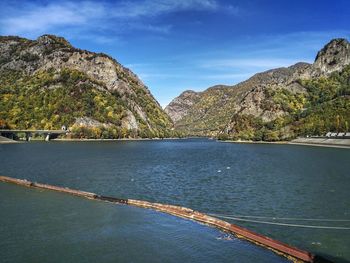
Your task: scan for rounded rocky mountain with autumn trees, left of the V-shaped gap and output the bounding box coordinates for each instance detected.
[0,35,174,138]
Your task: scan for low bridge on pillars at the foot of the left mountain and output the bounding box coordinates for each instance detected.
[0,129,70,141]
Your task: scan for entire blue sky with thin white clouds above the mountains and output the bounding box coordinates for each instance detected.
[0,0,350,106]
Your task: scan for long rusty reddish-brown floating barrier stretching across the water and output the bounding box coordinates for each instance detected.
[0,176,330,263]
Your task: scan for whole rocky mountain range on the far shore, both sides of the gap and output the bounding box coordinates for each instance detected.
[0,35,350,141]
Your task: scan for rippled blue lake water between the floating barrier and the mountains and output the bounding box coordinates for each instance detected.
[0,139,350,262]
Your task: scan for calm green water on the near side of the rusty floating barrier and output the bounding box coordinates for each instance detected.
[0,183,287,263]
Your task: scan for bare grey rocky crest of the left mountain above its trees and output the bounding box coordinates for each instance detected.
[0,35,153,104]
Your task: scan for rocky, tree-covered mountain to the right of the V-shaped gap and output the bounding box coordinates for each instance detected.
[165,39,350,140]
